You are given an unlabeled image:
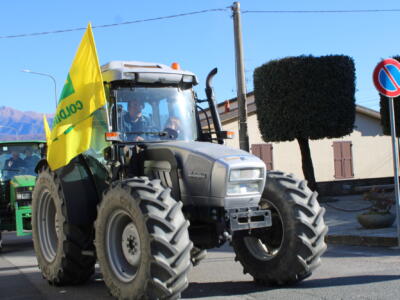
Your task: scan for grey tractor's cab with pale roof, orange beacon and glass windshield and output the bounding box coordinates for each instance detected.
[102,61,218,143]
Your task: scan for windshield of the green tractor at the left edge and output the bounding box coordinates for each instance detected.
[0,144,40,180]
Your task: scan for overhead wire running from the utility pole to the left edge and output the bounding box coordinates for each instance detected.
[0,8,228,39]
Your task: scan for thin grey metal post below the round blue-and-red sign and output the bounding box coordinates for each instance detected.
[389,97,400,247]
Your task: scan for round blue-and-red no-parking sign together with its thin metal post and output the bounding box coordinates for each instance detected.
[373,58,400,247]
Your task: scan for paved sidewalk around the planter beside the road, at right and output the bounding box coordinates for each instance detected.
[321,195,397,247]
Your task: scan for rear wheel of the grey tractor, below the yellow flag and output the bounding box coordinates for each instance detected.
[32,166,95,285]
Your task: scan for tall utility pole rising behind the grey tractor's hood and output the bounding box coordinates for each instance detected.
[231,2,249,151]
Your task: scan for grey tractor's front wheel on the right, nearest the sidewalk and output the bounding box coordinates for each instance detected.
[232,172,328,285]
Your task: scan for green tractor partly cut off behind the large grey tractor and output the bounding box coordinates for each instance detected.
[0,141,45,249]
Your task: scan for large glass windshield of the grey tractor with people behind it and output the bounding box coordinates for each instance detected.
[116,87,197,142]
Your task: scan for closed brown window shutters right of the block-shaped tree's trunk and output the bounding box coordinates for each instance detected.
[332,142,354,179]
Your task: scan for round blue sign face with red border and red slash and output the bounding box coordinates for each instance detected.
[373,58,400,97]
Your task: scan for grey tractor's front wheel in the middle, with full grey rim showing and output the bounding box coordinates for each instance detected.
[95,178,193,299]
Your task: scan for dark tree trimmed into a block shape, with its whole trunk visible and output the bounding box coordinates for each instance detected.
[254,55,355,190]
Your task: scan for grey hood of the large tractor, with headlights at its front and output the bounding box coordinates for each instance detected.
[148,141,266,208]
